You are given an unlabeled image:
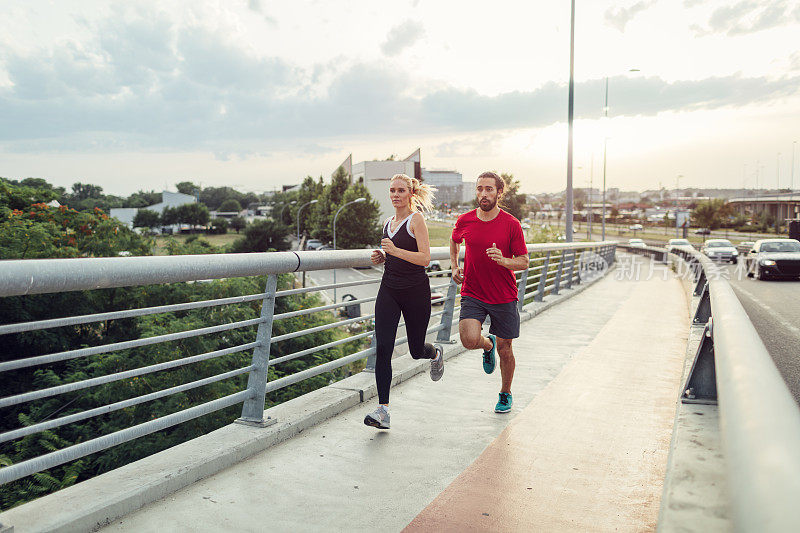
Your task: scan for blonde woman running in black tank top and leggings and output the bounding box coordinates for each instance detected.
[364,174,444,429]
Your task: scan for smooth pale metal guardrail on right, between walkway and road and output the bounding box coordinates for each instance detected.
[626,243,800,532]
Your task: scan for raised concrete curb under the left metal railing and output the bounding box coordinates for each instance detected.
[0,264,614,533]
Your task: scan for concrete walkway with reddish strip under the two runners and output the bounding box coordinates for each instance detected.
[101,260,688,531]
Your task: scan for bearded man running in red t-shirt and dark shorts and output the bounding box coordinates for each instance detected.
[450,172,528,413]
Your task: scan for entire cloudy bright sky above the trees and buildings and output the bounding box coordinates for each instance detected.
[0,0,800,195]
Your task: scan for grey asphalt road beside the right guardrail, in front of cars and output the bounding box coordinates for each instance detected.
[728,265,800,404]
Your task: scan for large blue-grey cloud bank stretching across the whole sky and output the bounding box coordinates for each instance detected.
[0,8,800,157]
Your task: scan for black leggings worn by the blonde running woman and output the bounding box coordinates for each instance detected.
[375,279,436,404]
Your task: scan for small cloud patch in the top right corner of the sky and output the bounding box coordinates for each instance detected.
[693,0,800,36]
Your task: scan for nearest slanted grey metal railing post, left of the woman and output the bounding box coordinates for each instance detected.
[236,274,278,427]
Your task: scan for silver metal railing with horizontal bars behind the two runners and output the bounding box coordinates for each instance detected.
[0,242,616,484]
